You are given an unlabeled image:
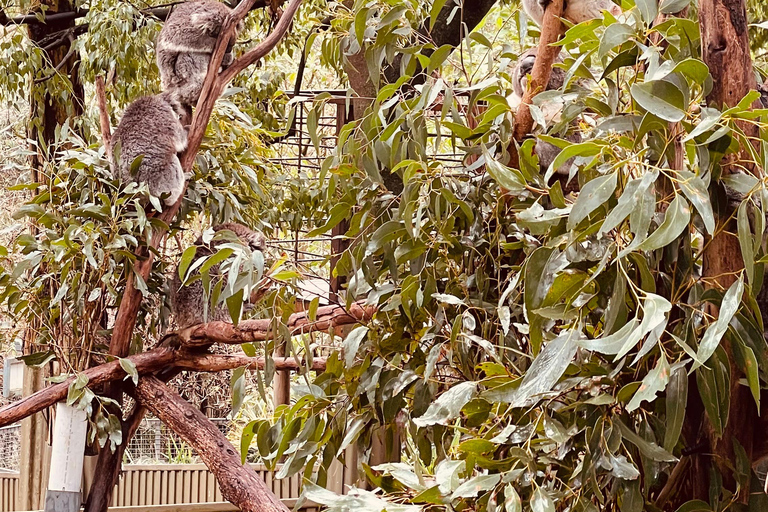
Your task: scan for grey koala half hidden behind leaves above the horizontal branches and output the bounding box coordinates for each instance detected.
[170,223,266,329]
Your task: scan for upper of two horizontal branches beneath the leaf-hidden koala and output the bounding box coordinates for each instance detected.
[175,302,376,347]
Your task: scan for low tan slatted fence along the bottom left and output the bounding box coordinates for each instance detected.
[0,461,357,512]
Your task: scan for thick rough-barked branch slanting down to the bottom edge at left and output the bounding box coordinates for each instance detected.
[135,377,288,512]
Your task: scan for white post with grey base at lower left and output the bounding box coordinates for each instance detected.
[45,402,88,512]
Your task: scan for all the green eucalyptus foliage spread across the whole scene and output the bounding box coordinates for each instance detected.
[0,0,768,512]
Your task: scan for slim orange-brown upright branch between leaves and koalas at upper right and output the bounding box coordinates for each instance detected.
[509,0,564,169]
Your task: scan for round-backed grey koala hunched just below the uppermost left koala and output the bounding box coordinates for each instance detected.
[110,93,187,206]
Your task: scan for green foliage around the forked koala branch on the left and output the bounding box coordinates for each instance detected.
[0,0,308,448]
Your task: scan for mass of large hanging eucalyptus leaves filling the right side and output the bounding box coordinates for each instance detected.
[242,1,768,512]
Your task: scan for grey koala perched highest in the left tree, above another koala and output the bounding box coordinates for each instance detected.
[156,0,242,111]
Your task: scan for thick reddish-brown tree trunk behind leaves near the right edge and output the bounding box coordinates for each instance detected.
[692,0,757,503]
